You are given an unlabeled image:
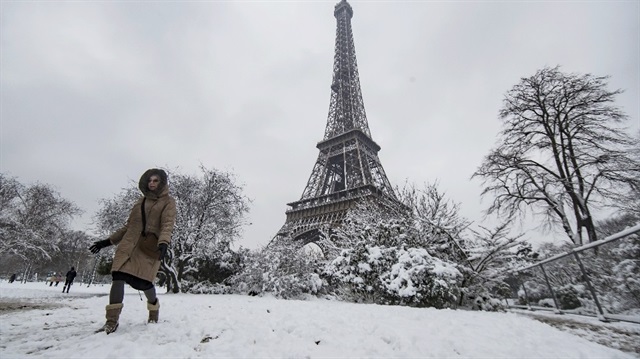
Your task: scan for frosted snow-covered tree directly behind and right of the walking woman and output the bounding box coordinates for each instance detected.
[161,166,250,293]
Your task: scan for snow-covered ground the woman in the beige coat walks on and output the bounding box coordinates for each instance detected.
[0,281,640,359]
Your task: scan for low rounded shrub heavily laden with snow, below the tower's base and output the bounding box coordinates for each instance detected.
[324,243,461,308]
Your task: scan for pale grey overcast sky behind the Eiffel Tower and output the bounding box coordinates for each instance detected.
[0,0,640,248]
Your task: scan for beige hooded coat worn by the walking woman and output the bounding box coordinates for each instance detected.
[109,170,176,283]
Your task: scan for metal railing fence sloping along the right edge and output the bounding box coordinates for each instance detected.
[507,224,640,323]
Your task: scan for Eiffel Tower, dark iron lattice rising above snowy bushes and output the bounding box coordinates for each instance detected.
[276,0,398,242]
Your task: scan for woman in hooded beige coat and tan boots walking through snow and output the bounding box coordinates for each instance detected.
[89,168,176,334]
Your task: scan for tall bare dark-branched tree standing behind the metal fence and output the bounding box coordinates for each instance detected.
[472,67,640,245]
